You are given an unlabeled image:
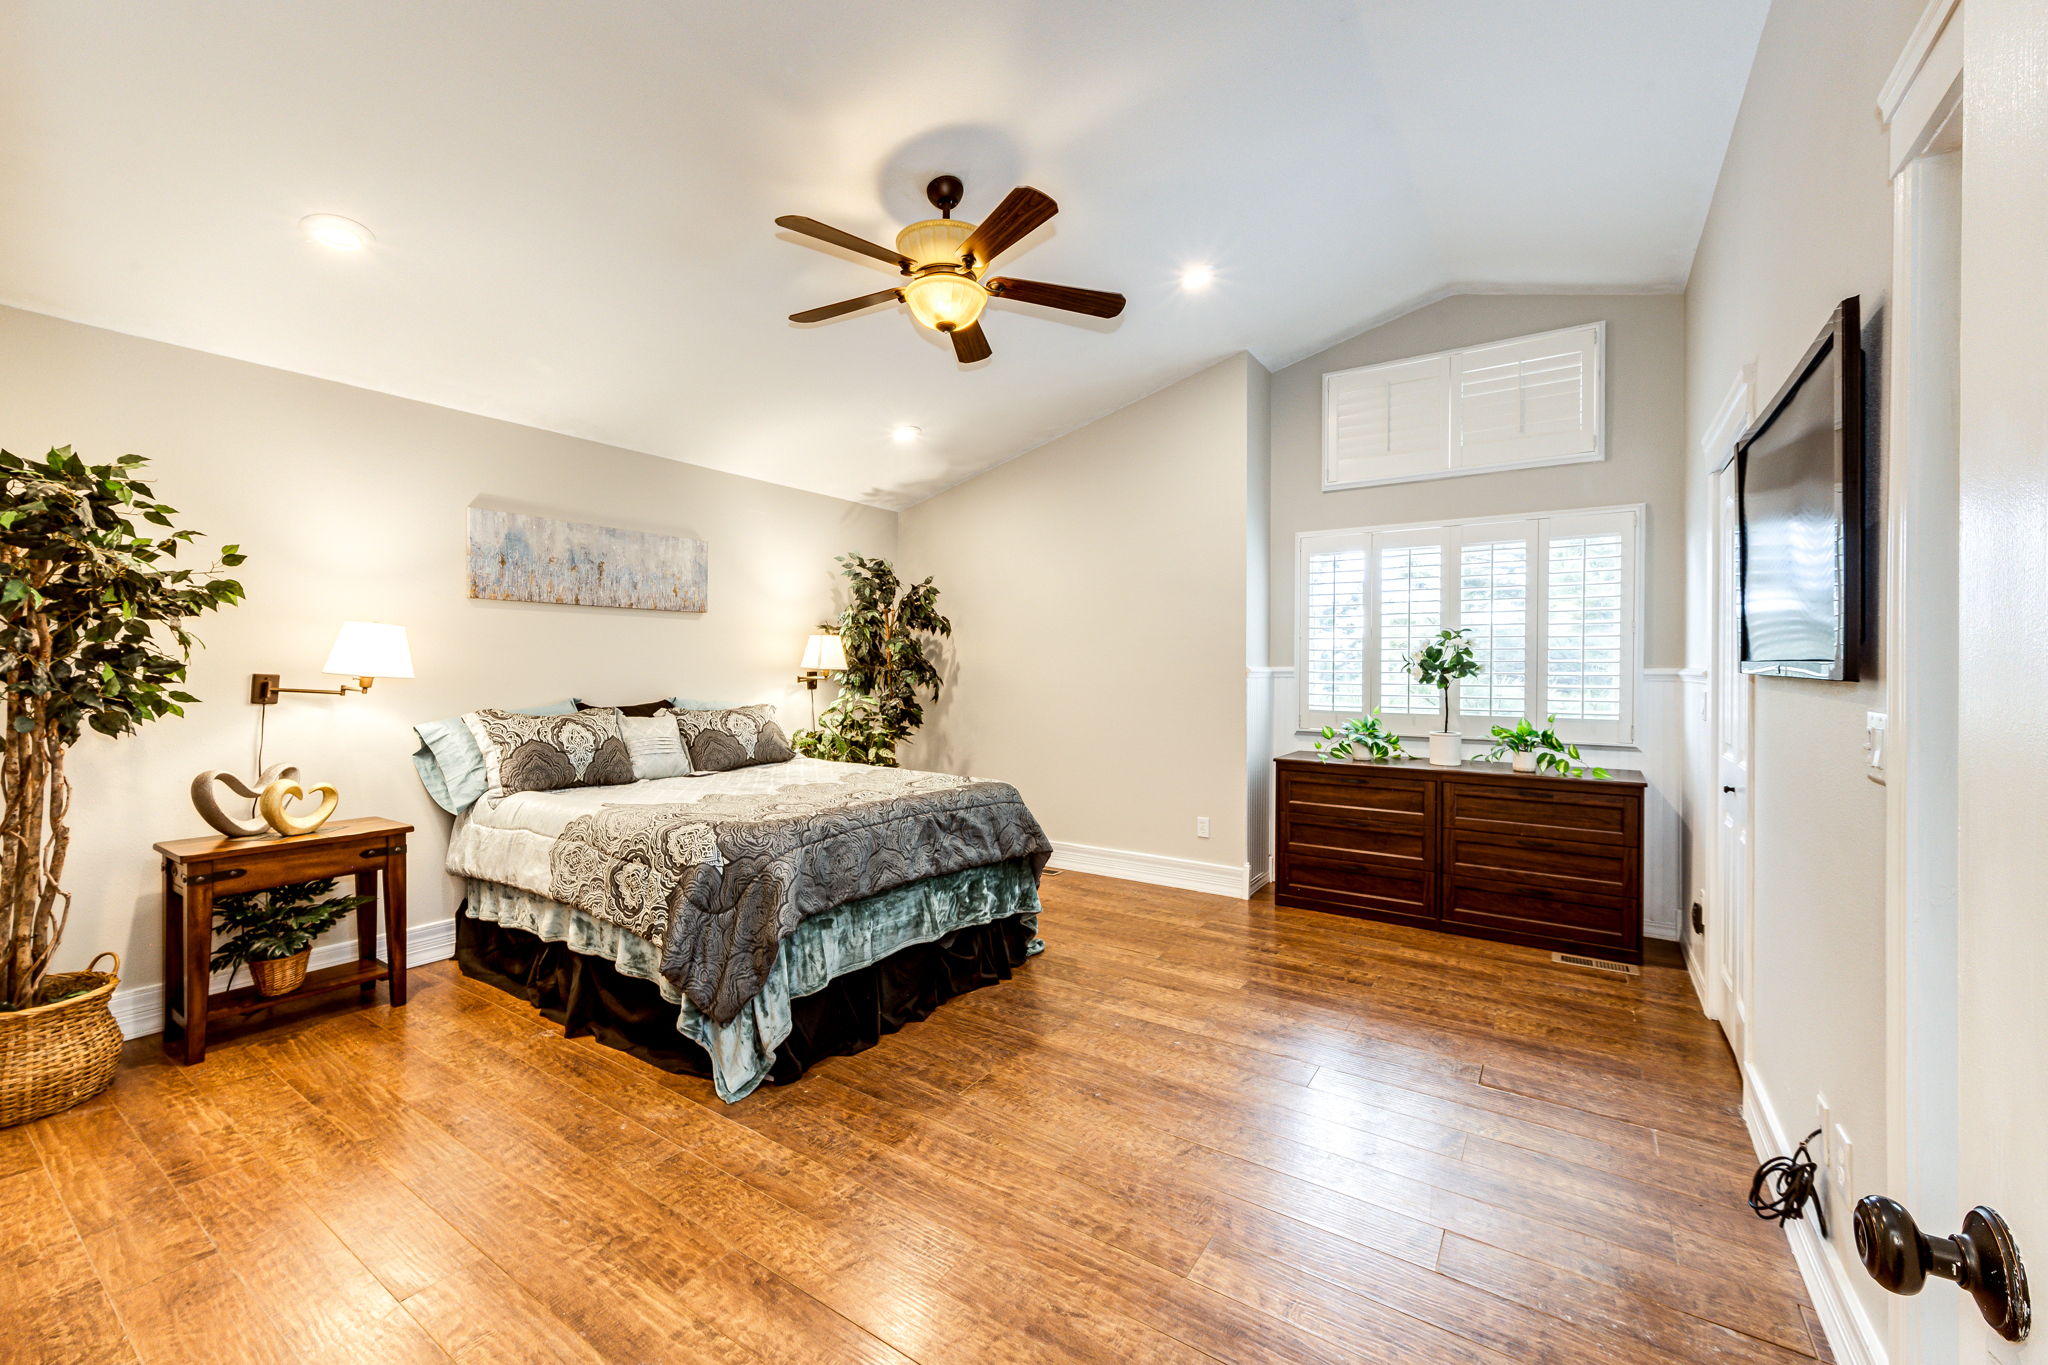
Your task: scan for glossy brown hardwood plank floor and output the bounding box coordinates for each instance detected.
[0,874,1825,1365]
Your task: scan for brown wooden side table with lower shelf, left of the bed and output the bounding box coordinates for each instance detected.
[156,817,412,1064]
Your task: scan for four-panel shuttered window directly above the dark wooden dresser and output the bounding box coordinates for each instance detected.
[1296,508,1642,745]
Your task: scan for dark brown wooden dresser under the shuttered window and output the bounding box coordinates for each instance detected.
[1274,753,1645,962]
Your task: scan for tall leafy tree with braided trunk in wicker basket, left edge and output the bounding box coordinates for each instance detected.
[0,446,242,1126]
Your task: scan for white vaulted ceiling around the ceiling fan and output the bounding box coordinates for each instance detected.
[0,0,1767,505]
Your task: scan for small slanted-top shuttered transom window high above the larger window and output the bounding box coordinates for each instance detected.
[1323,323,1608,489]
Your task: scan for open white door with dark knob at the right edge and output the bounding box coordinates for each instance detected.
[1929,0,2048,1365]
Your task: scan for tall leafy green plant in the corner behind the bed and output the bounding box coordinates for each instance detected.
[791,555,952,767]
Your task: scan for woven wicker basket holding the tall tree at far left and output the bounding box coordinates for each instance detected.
[0,954,121,1128]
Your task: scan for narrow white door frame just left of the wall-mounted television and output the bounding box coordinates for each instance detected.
[1700,374,1755,1064]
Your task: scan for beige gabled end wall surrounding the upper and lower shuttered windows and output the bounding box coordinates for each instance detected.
[1268,295,1686,667]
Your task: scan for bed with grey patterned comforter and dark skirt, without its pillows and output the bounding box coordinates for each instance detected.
[449,757,1051,1103]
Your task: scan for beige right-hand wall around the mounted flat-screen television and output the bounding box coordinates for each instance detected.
[1686,0,1921,1322]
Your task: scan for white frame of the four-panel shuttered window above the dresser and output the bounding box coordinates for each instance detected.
[1294,503,1647,749]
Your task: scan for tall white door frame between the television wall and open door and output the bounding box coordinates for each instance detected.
[1875,0,1962,1363]
